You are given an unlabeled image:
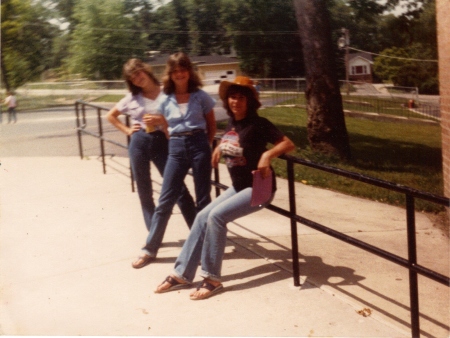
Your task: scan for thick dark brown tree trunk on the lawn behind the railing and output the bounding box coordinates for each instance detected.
[293,0,351,159]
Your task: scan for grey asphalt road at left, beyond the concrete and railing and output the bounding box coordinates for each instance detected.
[0,101,227,159]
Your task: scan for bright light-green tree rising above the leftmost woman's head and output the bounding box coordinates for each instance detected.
[67,0,147,80]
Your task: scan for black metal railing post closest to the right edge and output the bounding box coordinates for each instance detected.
[406,194,420,338]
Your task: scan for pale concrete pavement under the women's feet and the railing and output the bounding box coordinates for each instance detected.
[0,157,450,337]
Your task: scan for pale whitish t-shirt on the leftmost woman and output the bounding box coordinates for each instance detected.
[116,91,167,129]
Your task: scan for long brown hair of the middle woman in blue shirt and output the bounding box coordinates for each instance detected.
[162,52,203,94]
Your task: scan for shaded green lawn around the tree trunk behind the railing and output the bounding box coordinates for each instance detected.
[219,108,443,212]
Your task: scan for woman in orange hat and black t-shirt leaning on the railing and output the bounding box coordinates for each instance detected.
[155,76,295,300]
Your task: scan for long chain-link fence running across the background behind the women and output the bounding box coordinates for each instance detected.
[13,78,440,120]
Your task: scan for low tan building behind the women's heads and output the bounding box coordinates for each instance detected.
[145,52,241,85]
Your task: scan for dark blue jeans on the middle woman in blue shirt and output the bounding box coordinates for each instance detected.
[142,132,212,257]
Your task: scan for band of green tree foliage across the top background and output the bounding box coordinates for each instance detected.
[2,0,436,86]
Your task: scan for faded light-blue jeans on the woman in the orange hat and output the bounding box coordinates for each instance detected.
[174,187,273,282]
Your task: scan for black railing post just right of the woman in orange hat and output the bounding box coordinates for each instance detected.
[286,159,300,286]
